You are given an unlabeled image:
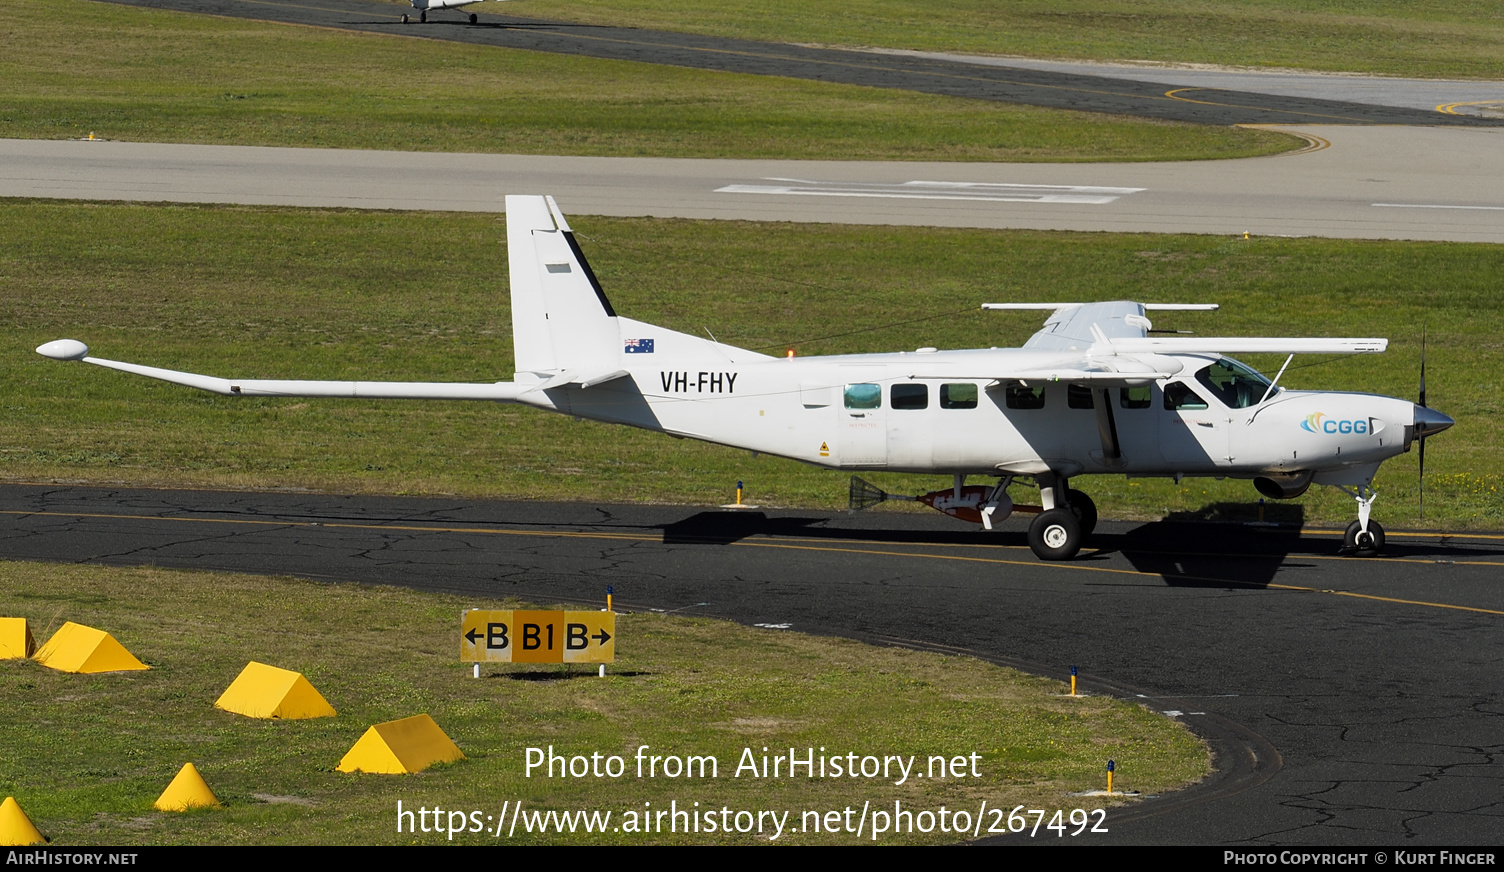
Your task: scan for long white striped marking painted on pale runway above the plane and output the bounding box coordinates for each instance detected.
[716,179,1145,206]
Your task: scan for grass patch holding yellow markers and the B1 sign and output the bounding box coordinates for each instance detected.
[0,564,1209,846]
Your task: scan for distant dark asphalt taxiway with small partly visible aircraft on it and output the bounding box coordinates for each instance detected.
[85,0,1501,126]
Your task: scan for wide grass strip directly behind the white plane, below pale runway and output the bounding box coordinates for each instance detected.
[0,201,1504,528]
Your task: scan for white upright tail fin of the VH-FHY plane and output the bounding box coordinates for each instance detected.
[507,195,621,377]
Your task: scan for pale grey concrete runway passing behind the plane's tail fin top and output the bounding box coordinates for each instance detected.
[0,125,1504,242]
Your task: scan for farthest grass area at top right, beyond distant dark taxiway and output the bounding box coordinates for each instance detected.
[511,0,1504,78]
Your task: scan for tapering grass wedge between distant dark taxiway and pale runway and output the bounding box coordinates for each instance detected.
[0,0,1301,161]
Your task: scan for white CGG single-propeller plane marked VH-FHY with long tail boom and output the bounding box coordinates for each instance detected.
[38,197,1453,559]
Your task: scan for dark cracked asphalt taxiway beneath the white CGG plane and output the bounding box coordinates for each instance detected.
[0,484,1504,845]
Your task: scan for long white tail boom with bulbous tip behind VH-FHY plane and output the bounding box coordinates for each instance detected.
[36,340,523,401]
